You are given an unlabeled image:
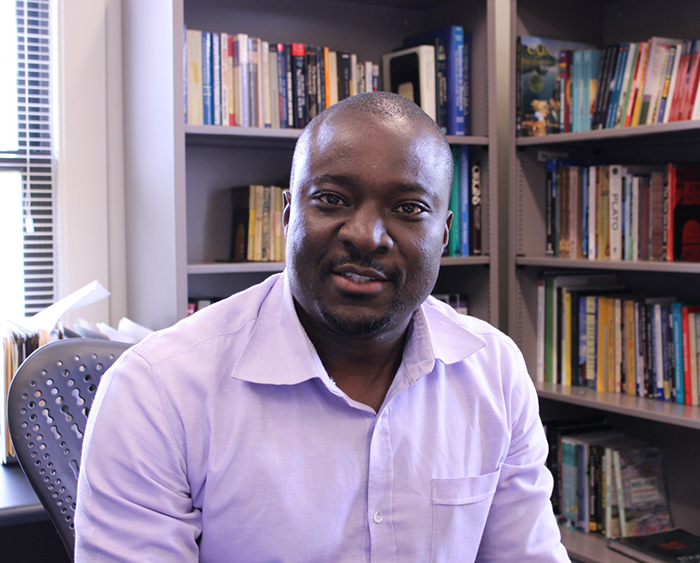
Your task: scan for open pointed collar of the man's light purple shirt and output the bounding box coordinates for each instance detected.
[231,271,486,385]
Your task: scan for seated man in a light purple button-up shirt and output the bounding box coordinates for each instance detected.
[76,93,568,563]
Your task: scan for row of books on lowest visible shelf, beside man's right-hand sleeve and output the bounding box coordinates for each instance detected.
[545,421,672,538]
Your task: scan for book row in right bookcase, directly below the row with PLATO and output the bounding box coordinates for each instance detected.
[536,274,700,405]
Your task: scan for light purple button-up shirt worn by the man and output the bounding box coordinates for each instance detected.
[76,274,569,563]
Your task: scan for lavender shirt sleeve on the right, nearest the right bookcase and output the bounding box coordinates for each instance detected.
[477,350,570,563]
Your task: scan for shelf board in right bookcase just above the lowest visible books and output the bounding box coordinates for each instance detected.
[535,382,700,430]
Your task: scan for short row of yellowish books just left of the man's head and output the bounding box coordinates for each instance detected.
[230,184,285,262]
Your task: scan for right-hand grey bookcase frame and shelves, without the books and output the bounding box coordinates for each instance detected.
[507,0,700,563]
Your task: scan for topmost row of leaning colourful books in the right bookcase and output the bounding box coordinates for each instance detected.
[516,37,700,136]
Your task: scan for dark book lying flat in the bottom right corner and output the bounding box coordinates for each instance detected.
[608,528,700,563]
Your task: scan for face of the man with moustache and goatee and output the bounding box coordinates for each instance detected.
[284,112,451,337]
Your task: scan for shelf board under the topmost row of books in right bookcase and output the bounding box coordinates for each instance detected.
[516,120,700,147]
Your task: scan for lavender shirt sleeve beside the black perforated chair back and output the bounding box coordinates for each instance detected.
[75,351,201,563]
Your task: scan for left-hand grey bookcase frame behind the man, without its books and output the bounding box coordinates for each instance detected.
[122,0,499,328]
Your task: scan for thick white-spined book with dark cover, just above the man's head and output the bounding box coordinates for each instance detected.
[382,45,436,119]
